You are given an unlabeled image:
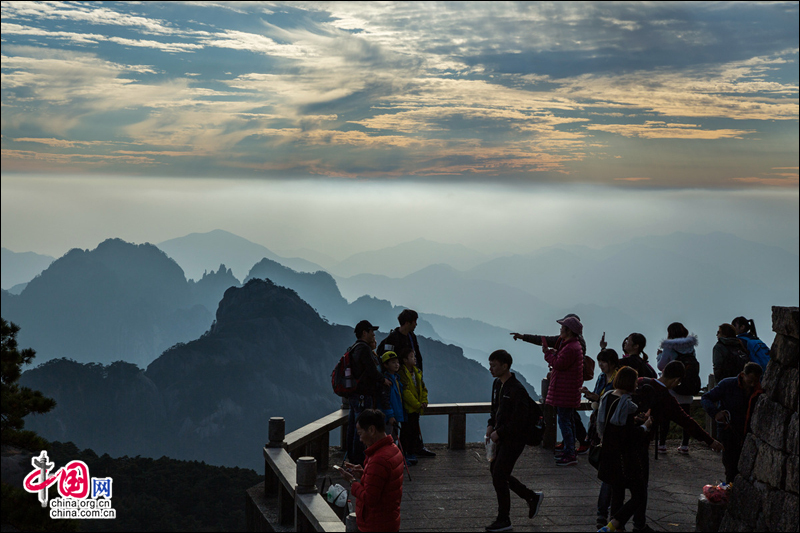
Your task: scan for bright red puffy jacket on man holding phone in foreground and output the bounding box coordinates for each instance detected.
[350,435,403,531]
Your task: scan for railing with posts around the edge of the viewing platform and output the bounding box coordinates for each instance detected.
[248,376,716,531]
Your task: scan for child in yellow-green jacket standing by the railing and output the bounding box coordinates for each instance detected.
[397,345,436,466]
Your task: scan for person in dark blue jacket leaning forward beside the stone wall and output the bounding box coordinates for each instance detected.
[702,362,764,483]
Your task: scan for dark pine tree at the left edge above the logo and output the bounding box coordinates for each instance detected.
[0,318,56,450]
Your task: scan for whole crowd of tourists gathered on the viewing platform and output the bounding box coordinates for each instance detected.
[332,309,769,532]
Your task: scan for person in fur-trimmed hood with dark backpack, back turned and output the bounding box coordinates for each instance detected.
[658,322,700,455]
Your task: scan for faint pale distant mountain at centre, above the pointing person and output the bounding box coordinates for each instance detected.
[329,239,500,278]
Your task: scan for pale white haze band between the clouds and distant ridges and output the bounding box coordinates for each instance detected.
[2,173,800,261]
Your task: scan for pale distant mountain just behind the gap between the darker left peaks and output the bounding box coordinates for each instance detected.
[157,230,322,278]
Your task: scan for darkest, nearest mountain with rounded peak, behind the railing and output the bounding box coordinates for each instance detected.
[20,279,500,469]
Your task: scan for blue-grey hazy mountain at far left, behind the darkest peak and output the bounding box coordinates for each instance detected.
[2,239,212,366]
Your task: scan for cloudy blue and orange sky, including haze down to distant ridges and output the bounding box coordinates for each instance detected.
[2,1,800,257]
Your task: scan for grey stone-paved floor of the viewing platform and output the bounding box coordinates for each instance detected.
[401,441,724,531]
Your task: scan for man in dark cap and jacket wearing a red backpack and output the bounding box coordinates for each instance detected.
[347,320,392,464]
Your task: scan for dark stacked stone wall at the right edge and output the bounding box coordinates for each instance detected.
[720,307,800,531]
